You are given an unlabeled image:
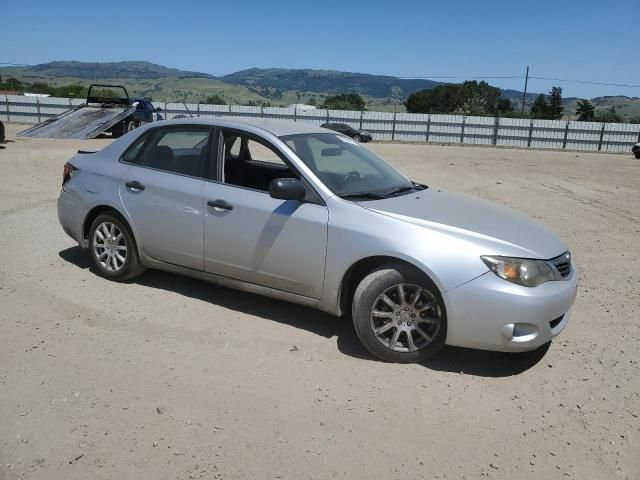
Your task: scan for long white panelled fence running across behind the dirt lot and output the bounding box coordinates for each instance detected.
[0,95,640,152]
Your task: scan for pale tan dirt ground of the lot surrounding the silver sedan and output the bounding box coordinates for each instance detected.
[0,125,640,480]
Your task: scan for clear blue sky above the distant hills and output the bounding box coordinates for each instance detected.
[0,0,640,97]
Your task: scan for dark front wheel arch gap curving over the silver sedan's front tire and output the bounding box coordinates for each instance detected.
[338,255,446,315]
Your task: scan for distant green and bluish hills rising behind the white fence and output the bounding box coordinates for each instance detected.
[0,61,640,119]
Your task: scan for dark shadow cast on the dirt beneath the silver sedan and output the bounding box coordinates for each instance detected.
[59,246,550,377]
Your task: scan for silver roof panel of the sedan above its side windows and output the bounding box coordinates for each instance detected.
[152,117,329,137]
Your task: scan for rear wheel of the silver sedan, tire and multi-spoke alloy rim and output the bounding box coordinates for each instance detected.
[89,212,145,282]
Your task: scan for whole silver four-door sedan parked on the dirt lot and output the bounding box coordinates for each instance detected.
[58,119,578,362]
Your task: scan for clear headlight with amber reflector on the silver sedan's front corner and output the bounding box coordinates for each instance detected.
[480,256,556,287]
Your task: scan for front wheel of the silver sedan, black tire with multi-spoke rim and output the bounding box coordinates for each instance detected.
[352,264,447,363]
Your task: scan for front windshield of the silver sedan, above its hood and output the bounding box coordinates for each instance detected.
[281,133,424,200]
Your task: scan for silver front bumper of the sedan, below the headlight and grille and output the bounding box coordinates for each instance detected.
[447,266,578,352]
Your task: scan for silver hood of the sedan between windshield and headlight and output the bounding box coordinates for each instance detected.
[359,188,567,259]
